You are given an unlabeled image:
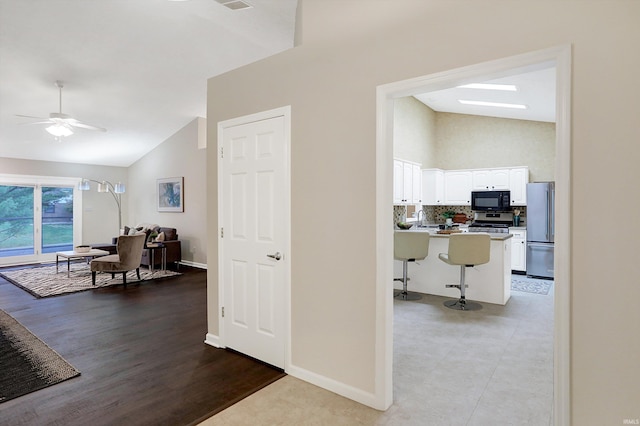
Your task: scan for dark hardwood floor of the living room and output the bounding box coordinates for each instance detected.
[0,267,284,426]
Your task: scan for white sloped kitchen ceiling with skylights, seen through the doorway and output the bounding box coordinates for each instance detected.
[415,62,556,122]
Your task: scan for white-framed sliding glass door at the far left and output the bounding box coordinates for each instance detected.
[0,175,82,265]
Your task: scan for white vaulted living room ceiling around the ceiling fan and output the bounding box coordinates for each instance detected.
[0,0,297,167]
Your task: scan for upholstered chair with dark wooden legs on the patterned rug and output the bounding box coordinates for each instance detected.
[91,233,146,286]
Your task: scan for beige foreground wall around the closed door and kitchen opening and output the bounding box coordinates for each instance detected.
[207,0,640,425]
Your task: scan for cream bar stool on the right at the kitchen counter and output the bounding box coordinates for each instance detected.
[438,232,491,311]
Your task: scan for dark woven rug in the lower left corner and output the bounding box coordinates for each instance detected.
[0,310,80,403]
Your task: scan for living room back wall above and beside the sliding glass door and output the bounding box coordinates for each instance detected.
[0,158,129,244]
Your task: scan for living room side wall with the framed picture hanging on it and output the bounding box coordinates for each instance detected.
[126,119,209,267]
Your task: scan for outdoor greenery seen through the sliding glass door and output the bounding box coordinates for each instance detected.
[0,185,73,257]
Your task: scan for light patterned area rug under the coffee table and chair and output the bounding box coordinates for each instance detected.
[0,262,180,297]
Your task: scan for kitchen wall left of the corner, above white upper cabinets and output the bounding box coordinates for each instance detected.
[393,96,438,169]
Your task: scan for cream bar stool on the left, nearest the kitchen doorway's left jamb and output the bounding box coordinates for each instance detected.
[393,231,429,300]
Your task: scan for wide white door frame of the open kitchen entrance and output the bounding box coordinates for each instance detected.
[375,45,571,425]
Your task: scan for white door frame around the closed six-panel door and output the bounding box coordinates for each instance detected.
[215,105,293,371]
